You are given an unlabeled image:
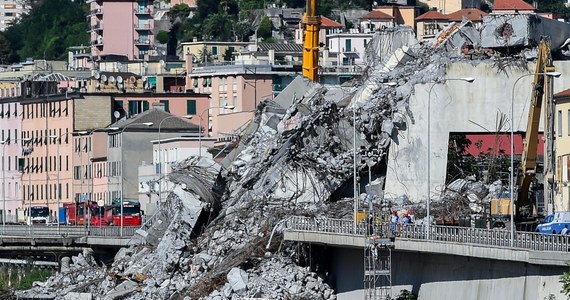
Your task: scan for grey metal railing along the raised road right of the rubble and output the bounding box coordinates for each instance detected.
[284,216,570,252]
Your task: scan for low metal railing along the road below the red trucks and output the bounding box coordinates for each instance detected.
[0,225,140,238]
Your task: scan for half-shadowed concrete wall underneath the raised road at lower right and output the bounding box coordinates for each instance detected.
[327,248,567,300]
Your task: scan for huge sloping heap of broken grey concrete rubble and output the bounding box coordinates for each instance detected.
[18,17,568,300]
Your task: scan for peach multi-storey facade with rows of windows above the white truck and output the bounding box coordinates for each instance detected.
[21,91,74,216]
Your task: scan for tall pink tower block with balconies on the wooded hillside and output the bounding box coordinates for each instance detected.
[87,0,154,60]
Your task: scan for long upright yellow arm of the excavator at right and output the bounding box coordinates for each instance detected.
[511,38,555,220]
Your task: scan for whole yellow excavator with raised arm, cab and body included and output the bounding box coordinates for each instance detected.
[490,37,555,231]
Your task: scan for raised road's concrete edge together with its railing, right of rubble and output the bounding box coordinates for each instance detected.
[284,217,570,266]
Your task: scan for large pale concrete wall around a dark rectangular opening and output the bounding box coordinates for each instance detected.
[385,61,570,202]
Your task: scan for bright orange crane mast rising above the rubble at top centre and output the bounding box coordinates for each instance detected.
[303,0,321,81]
